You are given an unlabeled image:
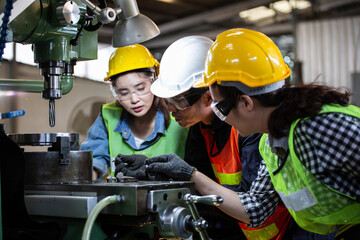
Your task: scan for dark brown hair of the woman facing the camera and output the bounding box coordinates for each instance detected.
[110,69,170,129]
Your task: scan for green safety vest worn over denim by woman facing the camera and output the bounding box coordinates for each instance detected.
[101,102,189,176]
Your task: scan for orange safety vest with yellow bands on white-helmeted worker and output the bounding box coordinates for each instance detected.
[200,127,291,240]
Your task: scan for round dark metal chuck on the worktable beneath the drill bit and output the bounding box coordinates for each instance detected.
[8,133,93,184]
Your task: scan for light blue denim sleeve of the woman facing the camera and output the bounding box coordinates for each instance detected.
[80,115,110,179]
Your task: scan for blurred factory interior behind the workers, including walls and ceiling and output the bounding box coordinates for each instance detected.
[0,0,360,144]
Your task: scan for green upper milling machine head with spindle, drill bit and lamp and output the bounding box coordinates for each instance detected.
[0,0,160,126]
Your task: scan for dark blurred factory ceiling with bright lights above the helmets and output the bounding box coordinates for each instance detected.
[94,0,360,56]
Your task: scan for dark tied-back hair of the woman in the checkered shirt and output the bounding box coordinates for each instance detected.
[215,83,351,138]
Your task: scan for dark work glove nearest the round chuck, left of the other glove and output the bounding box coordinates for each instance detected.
[115,153,148,180]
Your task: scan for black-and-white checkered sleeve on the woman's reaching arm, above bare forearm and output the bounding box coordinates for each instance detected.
[238,160,280,227]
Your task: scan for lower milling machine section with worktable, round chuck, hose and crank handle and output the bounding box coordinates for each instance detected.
[1,130,222,239]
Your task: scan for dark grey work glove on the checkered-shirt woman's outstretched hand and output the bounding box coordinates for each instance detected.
[146,153,196,181]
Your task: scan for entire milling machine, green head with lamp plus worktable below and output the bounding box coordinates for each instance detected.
[0,0,222,239]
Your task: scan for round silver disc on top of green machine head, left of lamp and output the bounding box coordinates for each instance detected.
[56,1,80,26]
